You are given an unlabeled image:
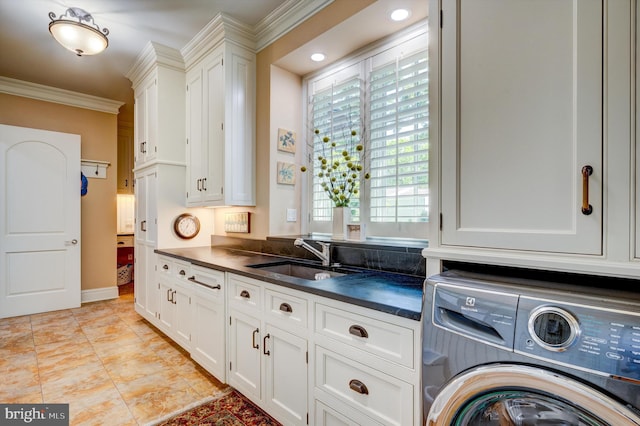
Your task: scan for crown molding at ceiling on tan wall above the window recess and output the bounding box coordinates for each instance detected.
[253,0,334,52]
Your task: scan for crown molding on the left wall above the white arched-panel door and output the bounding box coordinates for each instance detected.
[0,76,124,114]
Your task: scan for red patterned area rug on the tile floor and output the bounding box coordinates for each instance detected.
[157,390,280,426]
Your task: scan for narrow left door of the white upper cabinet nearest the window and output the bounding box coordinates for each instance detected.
[187,68,205,206]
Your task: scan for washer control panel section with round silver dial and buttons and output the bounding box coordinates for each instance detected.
[514,295,640,380]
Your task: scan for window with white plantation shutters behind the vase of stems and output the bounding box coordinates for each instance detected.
[306,25,429,239]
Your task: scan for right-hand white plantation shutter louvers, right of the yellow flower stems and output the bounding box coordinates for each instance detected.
[369,46,429,223]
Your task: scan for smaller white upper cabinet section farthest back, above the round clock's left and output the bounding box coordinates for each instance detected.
[127,42,185,169]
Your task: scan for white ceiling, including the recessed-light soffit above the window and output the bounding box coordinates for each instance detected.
[0,0,427,107]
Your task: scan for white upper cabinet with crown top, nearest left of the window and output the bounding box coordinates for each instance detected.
[183,16,256,206]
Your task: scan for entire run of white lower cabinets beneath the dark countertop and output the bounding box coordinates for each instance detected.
[147,262,422,426]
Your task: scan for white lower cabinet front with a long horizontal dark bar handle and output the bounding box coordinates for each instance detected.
[188,266,227,383]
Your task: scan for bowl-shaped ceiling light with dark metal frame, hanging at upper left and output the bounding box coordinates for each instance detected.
[49,7,109,56]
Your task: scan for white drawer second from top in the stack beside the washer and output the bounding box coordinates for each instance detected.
[315,346,414,426]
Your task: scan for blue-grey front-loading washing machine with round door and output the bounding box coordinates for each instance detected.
[423,271,640,426]
